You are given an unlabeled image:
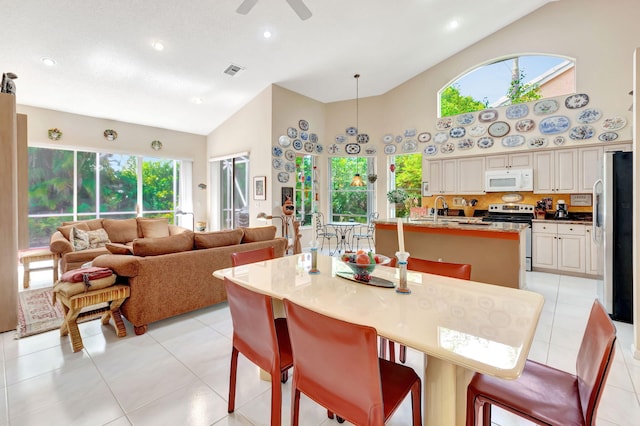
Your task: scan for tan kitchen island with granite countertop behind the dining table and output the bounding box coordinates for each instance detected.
[375,217,528,288]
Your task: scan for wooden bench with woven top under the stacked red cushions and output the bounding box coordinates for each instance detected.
[56,284,130,352]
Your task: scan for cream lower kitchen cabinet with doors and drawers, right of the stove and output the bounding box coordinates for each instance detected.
[531,222,595,274]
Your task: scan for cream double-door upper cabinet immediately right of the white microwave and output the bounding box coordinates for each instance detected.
[533,148,578,194]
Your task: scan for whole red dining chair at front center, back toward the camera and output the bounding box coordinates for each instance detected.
[284,299,422,426]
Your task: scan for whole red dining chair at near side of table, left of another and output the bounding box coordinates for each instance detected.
[224,277,293,426]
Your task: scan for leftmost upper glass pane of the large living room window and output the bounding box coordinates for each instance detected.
[28,148,74,214]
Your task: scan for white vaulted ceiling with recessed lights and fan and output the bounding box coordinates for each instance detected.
[0,0,549,135]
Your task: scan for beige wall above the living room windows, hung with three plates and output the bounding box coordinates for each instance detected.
[18,105,206,220]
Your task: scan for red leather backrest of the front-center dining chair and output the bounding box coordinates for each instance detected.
[284,299,384,425]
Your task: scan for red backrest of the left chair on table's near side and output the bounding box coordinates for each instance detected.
[224,278,280,371]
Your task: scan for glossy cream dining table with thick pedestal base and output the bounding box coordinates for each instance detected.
[214,253,544,426]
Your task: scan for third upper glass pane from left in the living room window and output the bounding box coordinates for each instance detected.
[100,154,138,213]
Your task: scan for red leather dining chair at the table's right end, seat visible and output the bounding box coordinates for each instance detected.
[467,300,616,426]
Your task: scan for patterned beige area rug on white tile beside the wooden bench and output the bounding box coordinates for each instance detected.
[16,287,64,339]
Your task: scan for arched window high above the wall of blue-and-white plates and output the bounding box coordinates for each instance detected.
[438,55,576,117]
